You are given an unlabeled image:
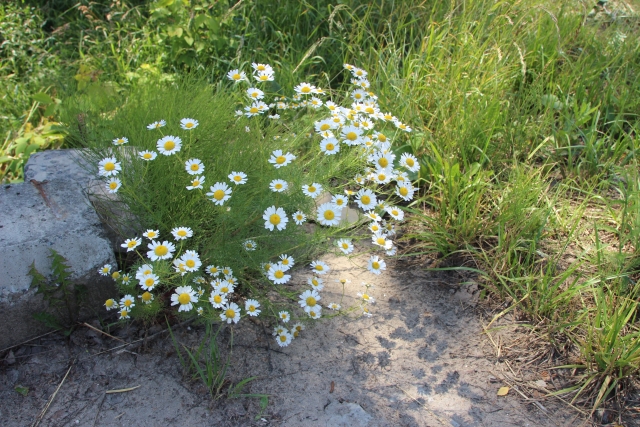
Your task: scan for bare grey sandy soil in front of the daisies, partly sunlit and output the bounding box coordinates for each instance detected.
[0,251,591,427]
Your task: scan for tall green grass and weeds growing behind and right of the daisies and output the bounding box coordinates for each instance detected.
[7,0,640,414]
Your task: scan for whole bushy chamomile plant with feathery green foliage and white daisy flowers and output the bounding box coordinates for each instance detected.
[87,64,418,346]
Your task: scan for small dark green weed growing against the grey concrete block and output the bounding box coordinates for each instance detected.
[29,249,86,335]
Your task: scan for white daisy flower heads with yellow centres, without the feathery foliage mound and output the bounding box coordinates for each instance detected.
[98,63,419,346]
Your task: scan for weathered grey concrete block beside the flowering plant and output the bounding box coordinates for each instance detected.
[0,150,116,349]
